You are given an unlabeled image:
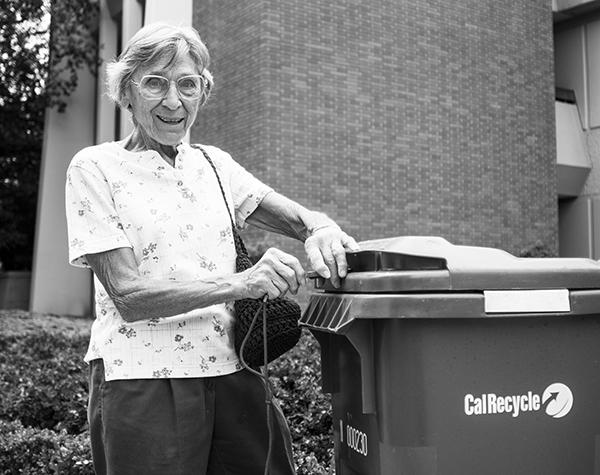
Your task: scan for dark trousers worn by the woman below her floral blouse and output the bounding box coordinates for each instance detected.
[88,360,295,475]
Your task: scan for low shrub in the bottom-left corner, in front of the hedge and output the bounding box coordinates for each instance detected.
[0,420,94,475]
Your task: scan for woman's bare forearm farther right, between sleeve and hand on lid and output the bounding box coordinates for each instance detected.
[247,192,338,242]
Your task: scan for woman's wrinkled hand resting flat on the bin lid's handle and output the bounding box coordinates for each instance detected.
[304,225,360,287]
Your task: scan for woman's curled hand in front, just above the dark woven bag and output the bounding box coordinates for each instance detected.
[237,248,306,299]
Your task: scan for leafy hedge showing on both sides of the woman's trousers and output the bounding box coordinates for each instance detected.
[0,311,333,475]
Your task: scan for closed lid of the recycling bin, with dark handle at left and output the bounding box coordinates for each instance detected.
[315,236,600,294]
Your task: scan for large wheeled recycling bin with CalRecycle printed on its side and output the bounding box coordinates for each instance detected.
[301,236,600,475]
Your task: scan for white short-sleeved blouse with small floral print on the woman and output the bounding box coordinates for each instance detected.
[66,142,272,381]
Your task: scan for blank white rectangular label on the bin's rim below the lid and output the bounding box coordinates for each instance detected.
[483,289,571,313]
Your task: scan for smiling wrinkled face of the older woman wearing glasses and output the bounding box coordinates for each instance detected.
[126,55,201,149]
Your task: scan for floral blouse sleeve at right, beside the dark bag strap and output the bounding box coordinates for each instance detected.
[204,147,273,229]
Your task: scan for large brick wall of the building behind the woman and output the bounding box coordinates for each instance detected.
[192,0,557,260]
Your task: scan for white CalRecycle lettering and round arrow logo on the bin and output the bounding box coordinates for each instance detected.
[464,383,573,419]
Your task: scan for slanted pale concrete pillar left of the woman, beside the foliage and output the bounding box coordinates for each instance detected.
[29,72,96,315]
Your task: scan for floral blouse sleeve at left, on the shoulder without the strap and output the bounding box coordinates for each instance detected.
[65,156,132,267]
